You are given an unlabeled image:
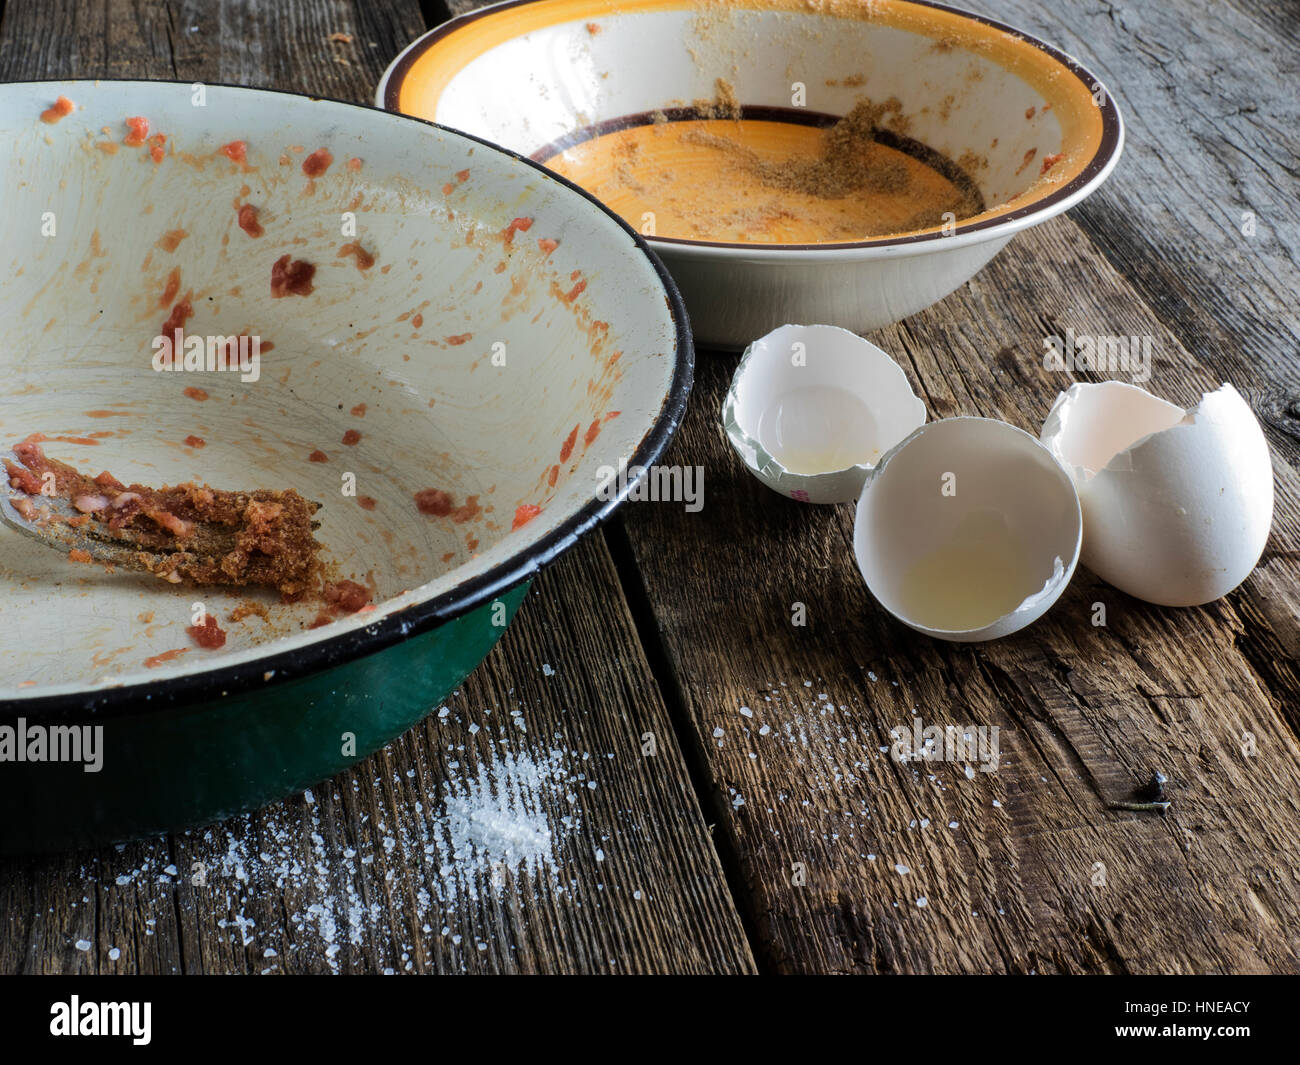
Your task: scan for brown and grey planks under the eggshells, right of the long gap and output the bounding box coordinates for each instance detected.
[623,0,1300,973]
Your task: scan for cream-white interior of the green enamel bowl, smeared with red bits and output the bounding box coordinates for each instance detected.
[0,82,679,698]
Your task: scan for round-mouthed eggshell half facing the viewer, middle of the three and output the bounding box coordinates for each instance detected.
[853,417,1083,642]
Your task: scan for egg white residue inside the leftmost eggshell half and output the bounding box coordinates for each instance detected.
[758,385,880,473]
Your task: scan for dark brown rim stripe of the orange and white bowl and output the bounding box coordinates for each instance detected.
[384,0,1123,255]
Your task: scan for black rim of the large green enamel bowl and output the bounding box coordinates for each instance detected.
[0,78,696,717]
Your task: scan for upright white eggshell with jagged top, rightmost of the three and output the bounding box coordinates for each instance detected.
[1041,381,1273,606]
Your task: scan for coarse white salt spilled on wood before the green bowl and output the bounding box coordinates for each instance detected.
[57,728,585,973]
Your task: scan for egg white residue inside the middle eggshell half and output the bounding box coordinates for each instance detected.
[897,507,1044,632]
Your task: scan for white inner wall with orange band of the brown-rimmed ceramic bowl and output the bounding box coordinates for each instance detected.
[380,0,1100,239]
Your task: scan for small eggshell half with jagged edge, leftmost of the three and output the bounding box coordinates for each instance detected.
[723,325,926,503]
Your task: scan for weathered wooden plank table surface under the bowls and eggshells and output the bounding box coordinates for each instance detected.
[0,0,1300,973]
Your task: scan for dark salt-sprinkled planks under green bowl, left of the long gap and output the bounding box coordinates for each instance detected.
[0,0,754,973]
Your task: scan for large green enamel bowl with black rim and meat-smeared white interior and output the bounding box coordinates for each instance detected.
[0,81,693,853]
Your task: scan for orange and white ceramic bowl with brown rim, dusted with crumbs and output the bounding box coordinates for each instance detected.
[377,0,1123,347]
